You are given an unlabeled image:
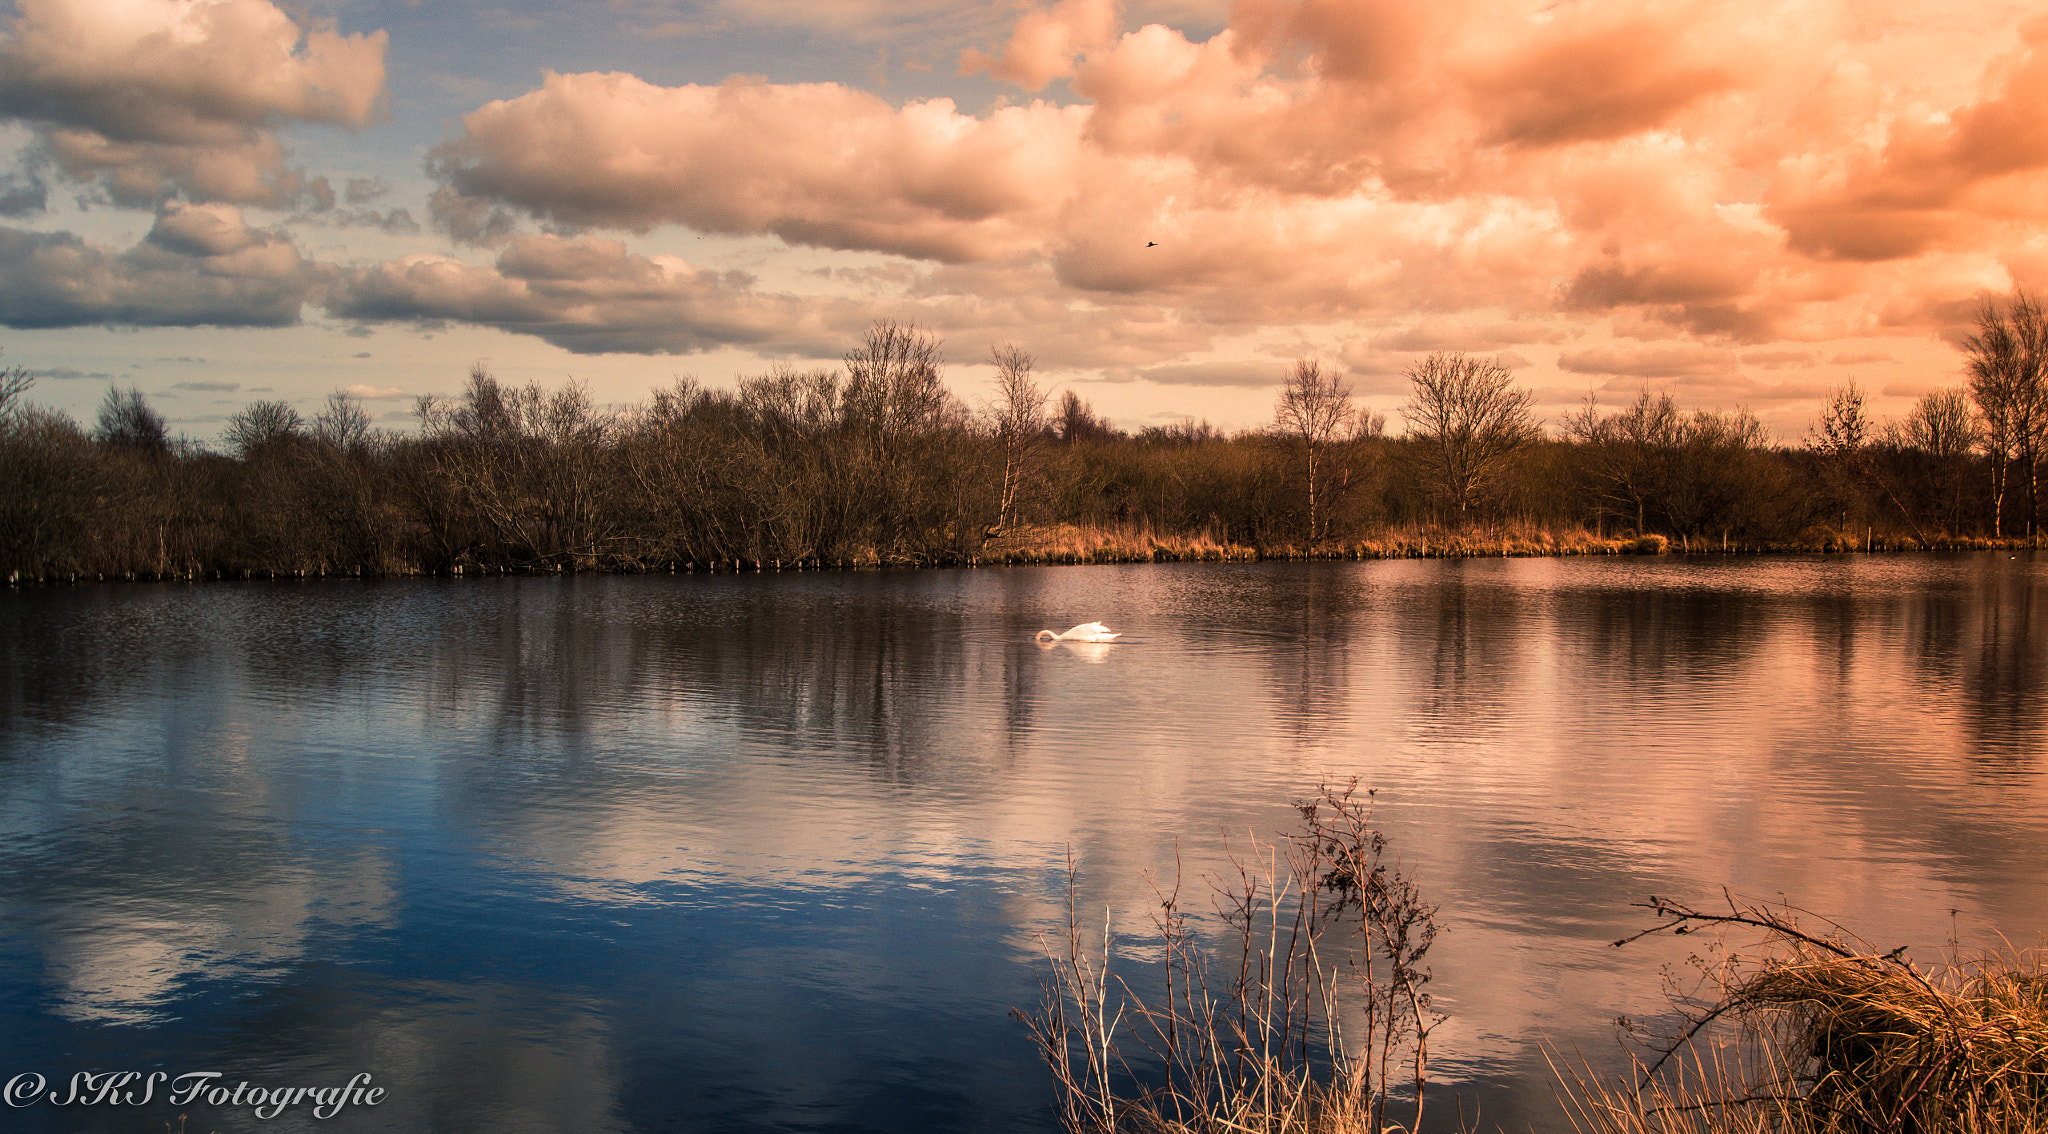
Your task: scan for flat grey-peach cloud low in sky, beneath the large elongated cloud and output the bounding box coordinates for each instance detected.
[324,235,864,354]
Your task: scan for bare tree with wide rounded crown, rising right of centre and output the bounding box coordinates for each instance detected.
[1401,352,1538,522]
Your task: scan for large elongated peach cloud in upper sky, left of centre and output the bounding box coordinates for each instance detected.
[428,74,1085,260]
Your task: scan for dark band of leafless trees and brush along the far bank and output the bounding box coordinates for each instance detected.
[0,309,2048,581]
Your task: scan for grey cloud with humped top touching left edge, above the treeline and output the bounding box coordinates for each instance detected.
[0,201,319,328]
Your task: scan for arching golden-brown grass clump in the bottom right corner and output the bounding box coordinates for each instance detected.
[1565,899,2048,1134]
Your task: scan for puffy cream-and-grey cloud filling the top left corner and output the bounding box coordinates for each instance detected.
[0,0,387,205]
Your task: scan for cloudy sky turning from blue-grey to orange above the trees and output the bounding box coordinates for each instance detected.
[0,0,2048,442]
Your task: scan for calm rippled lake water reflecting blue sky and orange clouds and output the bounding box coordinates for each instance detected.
[0,553,2048,1134]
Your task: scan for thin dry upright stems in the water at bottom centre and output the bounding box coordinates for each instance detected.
[1014,784,1440,1134]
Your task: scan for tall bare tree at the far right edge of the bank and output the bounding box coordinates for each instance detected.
[1962,291,2048,538]
